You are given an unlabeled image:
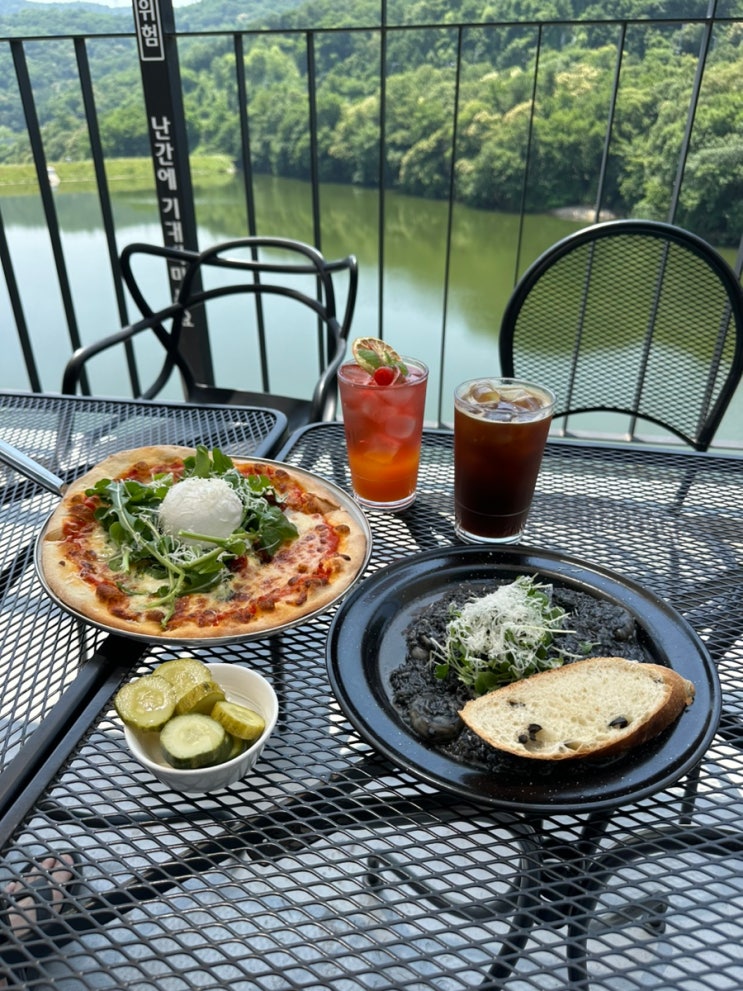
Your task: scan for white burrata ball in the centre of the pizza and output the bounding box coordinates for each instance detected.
[159,478,243,547]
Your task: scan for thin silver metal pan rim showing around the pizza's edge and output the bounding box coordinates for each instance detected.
[34,455,372,647]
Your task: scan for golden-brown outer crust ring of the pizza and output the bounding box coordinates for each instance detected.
[37,445,369,642]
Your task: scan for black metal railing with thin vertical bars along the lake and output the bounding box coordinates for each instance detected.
[0,0,743,446]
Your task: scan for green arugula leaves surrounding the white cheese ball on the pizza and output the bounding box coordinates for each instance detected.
[87,445,297,626]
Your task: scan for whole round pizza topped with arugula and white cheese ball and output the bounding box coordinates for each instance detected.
[38,446,369,640]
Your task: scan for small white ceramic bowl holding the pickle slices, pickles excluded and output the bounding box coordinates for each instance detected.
[124,664,279,795]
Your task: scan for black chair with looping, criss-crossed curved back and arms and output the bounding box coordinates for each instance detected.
[62,237,358,438]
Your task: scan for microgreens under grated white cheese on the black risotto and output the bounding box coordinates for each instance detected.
[434,575,570,695]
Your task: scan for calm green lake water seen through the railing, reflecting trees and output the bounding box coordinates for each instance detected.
[0,177,743,443]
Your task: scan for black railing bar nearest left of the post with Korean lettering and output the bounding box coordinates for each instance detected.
[75,38,142,396]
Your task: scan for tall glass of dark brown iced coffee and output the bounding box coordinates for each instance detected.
[454,378,555,543]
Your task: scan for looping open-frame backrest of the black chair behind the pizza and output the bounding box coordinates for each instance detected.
[121,237,358,421]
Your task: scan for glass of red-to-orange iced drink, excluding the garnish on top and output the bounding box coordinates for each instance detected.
[338,352,428,510]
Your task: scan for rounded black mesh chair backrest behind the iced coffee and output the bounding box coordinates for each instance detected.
[499,220,743,450]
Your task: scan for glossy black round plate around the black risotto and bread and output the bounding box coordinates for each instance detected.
[327,546,721,814]
